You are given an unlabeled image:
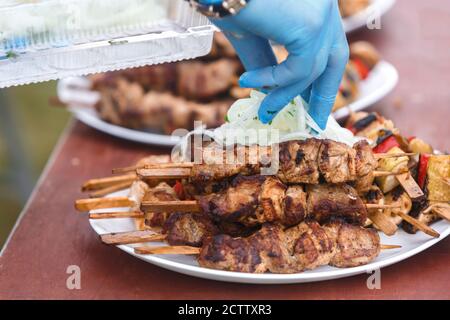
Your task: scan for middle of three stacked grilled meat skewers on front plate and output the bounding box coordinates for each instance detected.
[141,176,380,227]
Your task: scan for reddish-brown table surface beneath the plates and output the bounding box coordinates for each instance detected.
[0,0,450,299]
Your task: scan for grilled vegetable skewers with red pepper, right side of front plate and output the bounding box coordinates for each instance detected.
[346,112,450,233]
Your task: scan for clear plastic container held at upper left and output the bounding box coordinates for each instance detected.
[0,0,215,88]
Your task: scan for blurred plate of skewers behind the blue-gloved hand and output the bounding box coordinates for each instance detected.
[58,38,398,146]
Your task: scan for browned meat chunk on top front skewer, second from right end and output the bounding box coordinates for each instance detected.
[318,139,356,183]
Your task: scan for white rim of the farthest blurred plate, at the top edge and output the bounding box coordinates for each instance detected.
[343,0,395,33]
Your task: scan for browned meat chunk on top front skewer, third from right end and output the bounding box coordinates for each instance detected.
[279,139,322,184]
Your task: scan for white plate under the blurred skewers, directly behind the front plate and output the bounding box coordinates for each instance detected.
[58,61,398,146]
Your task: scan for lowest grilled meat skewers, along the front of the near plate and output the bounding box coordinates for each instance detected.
[101,209,399,273]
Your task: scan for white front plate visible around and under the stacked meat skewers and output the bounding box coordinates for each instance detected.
[90,191,450,284]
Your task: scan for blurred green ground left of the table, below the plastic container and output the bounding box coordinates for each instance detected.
[0,81,69,248]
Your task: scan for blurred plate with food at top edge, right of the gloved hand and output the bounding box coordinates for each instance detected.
[339,0,395,32]
